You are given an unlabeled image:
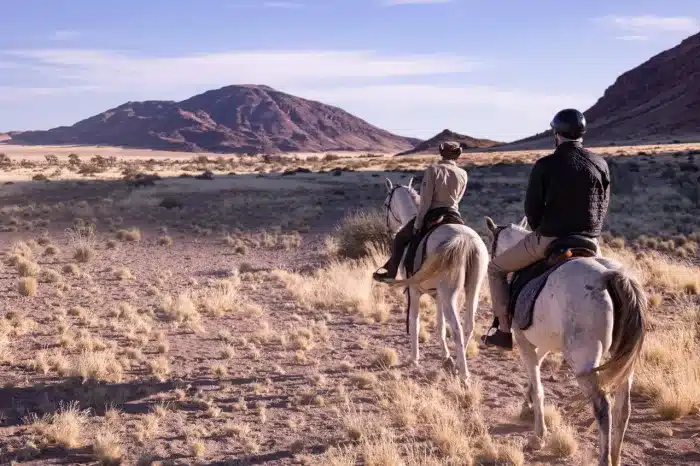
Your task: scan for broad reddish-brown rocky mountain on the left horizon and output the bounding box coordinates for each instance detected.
[6,85,420,153]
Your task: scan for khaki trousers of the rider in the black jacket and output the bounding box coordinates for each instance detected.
[488,232,556,332]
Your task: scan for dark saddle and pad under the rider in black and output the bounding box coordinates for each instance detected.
[508,235,598,330]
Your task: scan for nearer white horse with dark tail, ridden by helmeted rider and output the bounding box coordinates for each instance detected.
[485,217,648,466]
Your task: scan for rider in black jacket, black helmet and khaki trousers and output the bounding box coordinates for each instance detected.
[482,108,610,349]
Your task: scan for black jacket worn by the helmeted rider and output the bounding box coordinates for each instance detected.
[525,141,610,238]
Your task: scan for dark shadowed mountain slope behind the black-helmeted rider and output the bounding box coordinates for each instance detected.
[503,33,700,149]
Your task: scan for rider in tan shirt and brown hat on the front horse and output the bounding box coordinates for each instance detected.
[373,142,467,281]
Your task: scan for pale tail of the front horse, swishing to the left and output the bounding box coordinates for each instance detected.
[387,235,478,287]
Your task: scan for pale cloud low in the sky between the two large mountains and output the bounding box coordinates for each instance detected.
[290,84,596,141]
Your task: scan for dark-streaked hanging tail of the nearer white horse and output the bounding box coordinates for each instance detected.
[593,270,648,392]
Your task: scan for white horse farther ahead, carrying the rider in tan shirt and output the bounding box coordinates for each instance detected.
[384,178,489,382]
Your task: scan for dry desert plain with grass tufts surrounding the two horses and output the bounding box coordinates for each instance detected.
[0,144,700,466]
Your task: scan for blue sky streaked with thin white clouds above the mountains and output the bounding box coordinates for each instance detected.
[0,0,700,141]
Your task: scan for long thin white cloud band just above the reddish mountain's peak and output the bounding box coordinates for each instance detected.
[0,49,482,93]
